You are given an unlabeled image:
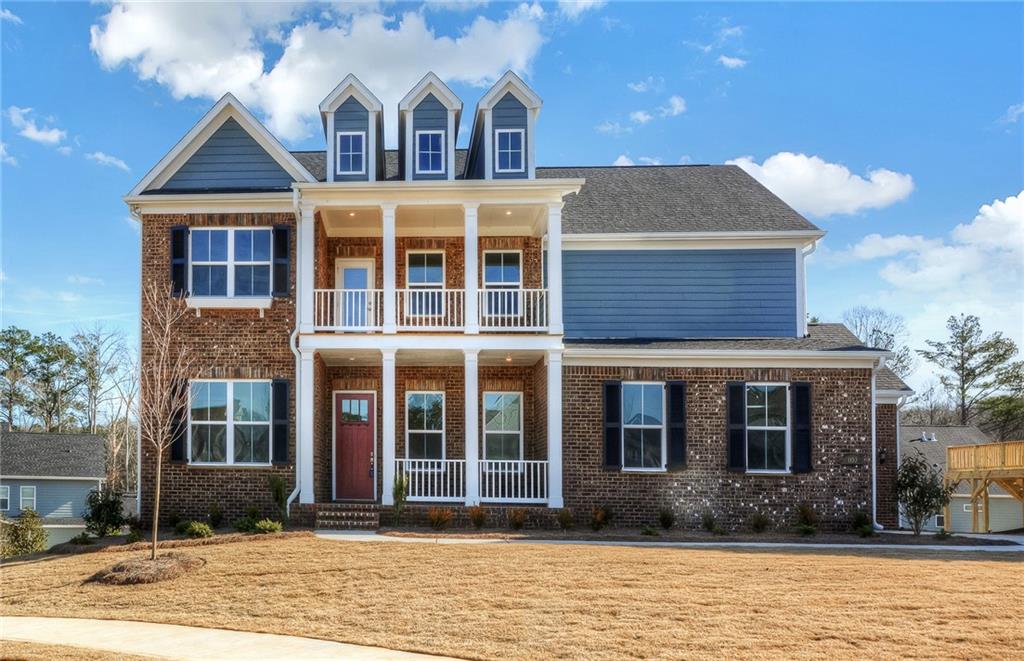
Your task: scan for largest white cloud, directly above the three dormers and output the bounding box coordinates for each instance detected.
[90,2,545,144]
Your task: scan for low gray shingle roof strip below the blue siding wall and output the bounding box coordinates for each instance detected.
[565,323,879,351]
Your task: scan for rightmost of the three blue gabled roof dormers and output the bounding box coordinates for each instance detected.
[466,72,544,179]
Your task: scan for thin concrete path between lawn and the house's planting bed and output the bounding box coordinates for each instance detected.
[315,530,1024,554]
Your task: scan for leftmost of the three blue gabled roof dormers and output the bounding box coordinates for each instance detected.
[319,74,384,181]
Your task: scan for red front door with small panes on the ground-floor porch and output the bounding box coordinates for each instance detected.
[334,393,376,500]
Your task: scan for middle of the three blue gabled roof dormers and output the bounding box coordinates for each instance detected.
[398,72,462,181]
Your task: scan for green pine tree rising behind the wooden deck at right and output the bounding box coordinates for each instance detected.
[919,314,1024,425]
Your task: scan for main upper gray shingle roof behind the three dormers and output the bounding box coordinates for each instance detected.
[292,149,818,234]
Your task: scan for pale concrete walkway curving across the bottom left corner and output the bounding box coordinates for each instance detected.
[0,616,456,661]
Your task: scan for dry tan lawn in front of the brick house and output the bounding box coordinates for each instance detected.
[0,537,1024,659]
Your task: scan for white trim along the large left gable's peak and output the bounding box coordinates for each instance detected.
[128,92,316,196]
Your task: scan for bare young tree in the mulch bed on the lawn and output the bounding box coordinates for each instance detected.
[138,281,194,560]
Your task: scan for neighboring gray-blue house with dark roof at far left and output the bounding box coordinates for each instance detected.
[0,432,106,545]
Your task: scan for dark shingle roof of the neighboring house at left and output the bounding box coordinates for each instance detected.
[0,432,106,479]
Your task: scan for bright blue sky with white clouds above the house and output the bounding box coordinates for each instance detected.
[0,2,1024,385]
